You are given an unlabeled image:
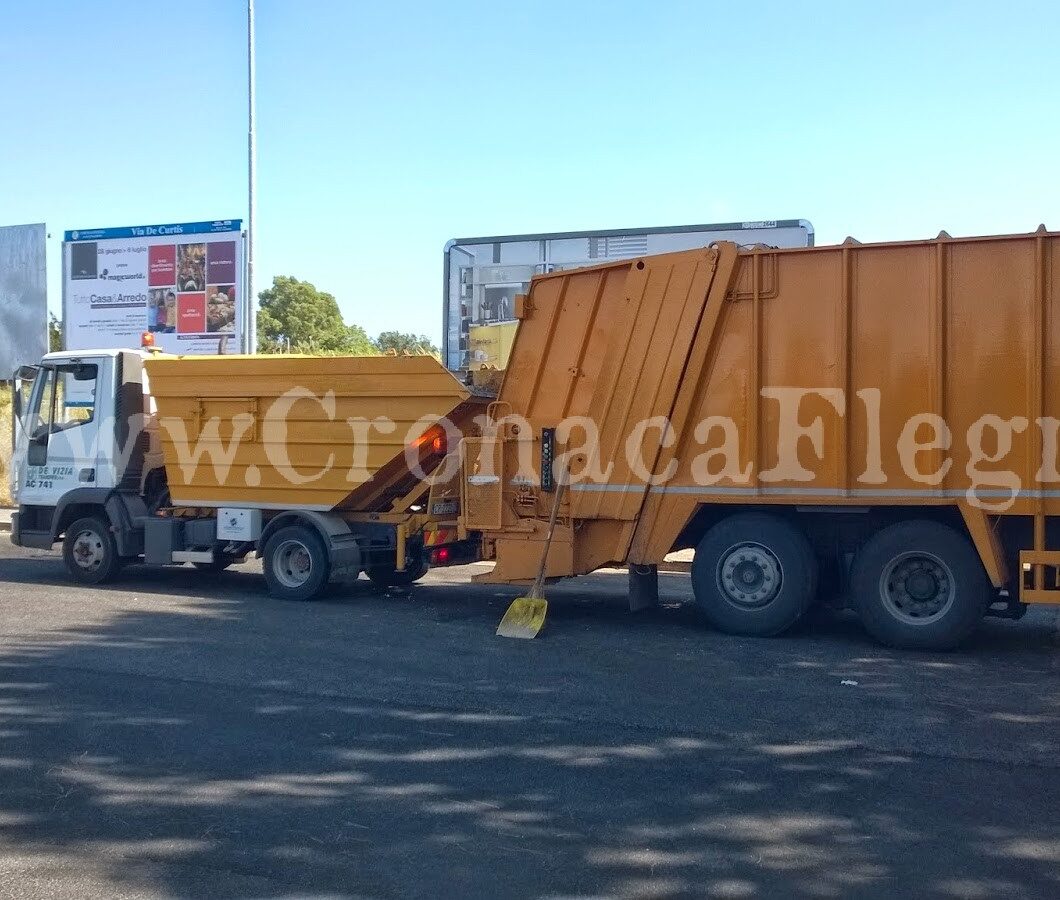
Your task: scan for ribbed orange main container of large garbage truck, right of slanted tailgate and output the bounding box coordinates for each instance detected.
[631,231,1060,562]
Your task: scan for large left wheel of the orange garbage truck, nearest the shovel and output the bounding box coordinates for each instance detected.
[692,512,817,637]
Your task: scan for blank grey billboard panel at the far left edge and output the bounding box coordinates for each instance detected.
[0,225,48,381]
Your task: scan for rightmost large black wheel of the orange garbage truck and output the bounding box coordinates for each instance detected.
[850,519,990,650]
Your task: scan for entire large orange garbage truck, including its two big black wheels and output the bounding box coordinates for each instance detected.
[460,227,1060,649]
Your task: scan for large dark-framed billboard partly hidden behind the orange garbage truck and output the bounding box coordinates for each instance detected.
[442,218,813,372]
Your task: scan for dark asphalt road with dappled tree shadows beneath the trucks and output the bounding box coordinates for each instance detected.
[0,542,1060,898]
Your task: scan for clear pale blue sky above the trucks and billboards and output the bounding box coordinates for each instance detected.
[0,0,1060,339]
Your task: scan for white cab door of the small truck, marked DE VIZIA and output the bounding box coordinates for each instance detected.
[13,357,113,506]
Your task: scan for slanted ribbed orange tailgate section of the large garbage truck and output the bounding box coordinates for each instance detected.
[483,245,736,561]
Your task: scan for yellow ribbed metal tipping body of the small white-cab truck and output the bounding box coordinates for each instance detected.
[145,356,467,509]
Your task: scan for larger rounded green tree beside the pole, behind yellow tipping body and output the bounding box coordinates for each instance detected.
[258,276,378,356]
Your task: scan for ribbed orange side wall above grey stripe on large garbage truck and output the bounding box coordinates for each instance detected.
[652,233,1060,500]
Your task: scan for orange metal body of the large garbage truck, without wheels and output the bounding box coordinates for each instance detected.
[463,229,1060,582]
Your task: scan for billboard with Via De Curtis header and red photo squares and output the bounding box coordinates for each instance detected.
[63,219,245,353]
